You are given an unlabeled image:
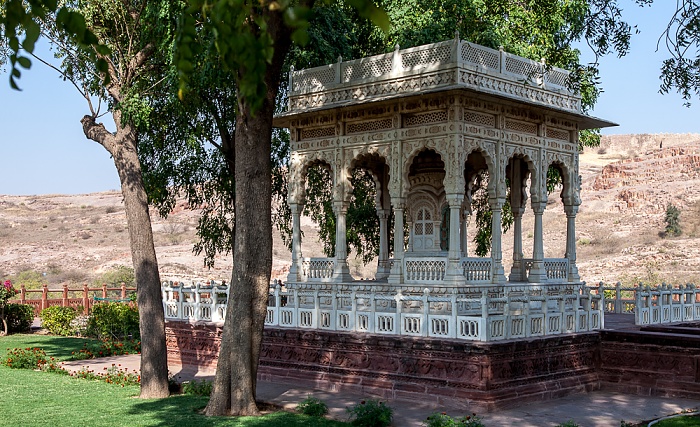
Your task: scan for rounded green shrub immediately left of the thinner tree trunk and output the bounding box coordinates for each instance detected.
[87,302,140,340]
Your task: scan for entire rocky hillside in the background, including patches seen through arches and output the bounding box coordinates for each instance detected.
[0,134,700,283]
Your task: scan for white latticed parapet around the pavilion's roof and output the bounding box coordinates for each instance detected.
[288,35,581,113]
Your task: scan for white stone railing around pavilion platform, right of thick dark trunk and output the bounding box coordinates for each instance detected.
[266,286,604,341]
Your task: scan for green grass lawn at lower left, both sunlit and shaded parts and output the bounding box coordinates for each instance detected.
[0,335,347,427]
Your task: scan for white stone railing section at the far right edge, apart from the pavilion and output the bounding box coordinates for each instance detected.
[634,284,700,325]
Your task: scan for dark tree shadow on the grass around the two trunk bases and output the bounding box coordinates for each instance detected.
[130,395,347,427]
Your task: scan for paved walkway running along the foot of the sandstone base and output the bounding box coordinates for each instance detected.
[64,355,700,427]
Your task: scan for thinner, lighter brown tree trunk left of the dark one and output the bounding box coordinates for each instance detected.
[81,112,170,399]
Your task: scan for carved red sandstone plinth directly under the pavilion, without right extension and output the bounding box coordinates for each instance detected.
[167,322,600,410]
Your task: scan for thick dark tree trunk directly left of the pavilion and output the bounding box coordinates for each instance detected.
[206,13,290,415]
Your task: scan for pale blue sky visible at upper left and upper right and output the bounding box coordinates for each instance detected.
[0,0,700,195]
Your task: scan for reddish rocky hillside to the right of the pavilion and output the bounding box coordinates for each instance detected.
[577,134,700,283]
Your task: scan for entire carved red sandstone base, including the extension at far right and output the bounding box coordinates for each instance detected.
[166,322,700,411]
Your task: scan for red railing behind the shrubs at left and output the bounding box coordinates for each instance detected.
[8,283,136,316]
